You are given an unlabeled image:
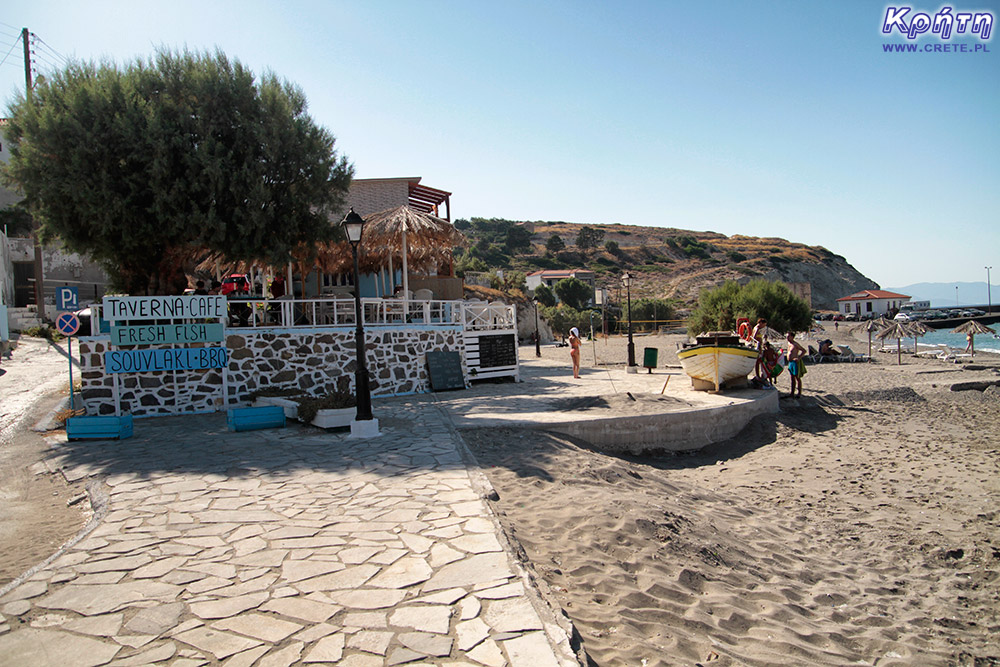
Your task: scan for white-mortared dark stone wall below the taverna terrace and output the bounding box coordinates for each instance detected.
[80,327,468,416]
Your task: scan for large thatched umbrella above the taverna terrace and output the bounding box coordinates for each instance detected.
[363,206,465,292]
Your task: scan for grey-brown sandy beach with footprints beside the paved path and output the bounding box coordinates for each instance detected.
[463,331,1000,666]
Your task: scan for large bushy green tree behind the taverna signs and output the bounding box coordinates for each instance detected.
[4,51,353,294]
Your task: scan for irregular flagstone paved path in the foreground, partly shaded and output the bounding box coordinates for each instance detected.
[0,400,576,667]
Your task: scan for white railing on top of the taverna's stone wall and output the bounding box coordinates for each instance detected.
[91,297,516,333]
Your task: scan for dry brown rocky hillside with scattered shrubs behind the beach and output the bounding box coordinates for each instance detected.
[456,218,878,309]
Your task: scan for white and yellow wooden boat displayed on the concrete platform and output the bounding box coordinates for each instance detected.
[677,331,757,391]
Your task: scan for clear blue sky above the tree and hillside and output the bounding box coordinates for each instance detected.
[0,0,1000,296]
